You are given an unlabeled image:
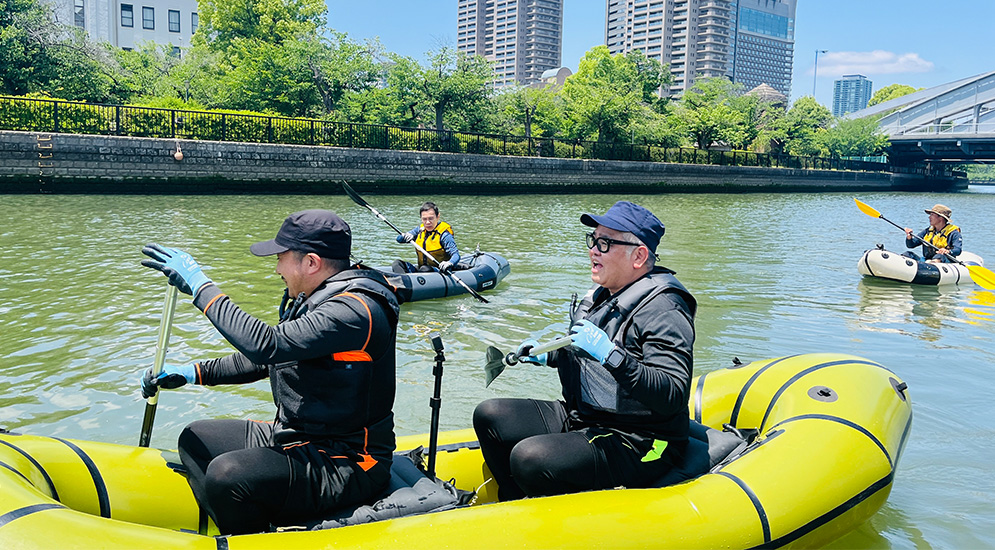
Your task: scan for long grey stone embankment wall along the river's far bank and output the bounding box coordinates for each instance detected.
[0,131,966,194]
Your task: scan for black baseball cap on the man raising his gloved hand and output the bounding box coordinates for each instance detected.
[249,210,352,260]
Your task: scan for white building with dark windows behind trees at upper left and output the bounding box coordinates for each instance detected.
[53,0,200,53]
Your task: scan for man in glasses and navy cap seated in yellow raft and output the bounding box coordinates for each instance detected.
[473,201,696,500]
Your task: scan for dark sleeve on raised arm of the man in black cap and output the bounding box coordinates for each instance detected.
[194,285,384,365]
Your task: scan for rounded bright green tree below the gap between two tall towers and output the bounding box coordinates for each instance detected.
[562,46,644,142]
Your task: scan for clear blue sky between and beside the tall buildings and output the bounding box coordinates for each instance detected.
[327,0,995,105]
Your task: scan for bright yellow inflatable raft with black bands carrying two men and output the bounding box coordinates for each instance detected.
[0,354,912,550]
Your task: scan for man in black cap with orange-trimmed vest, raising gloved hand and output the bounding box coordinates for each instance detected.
[142,210,399,534]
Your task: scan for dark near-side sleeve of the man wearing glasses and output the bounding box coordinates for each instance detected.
[611,293,694,414]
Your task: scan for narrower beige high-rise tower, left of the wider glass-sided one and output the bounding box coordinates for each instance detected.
[456,0,563,88]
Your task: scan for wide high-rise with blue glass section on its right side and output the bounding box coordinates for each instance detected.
[605,0,797,95]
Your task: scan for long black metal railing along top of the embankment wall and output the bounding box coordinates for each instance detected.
[0,96,894,172]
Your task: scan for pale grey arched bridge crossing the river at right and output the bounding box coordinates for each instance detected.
[847,71,995,166]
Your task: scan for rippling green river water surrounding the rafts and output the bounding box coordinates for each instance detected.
[0,187,995,548]
